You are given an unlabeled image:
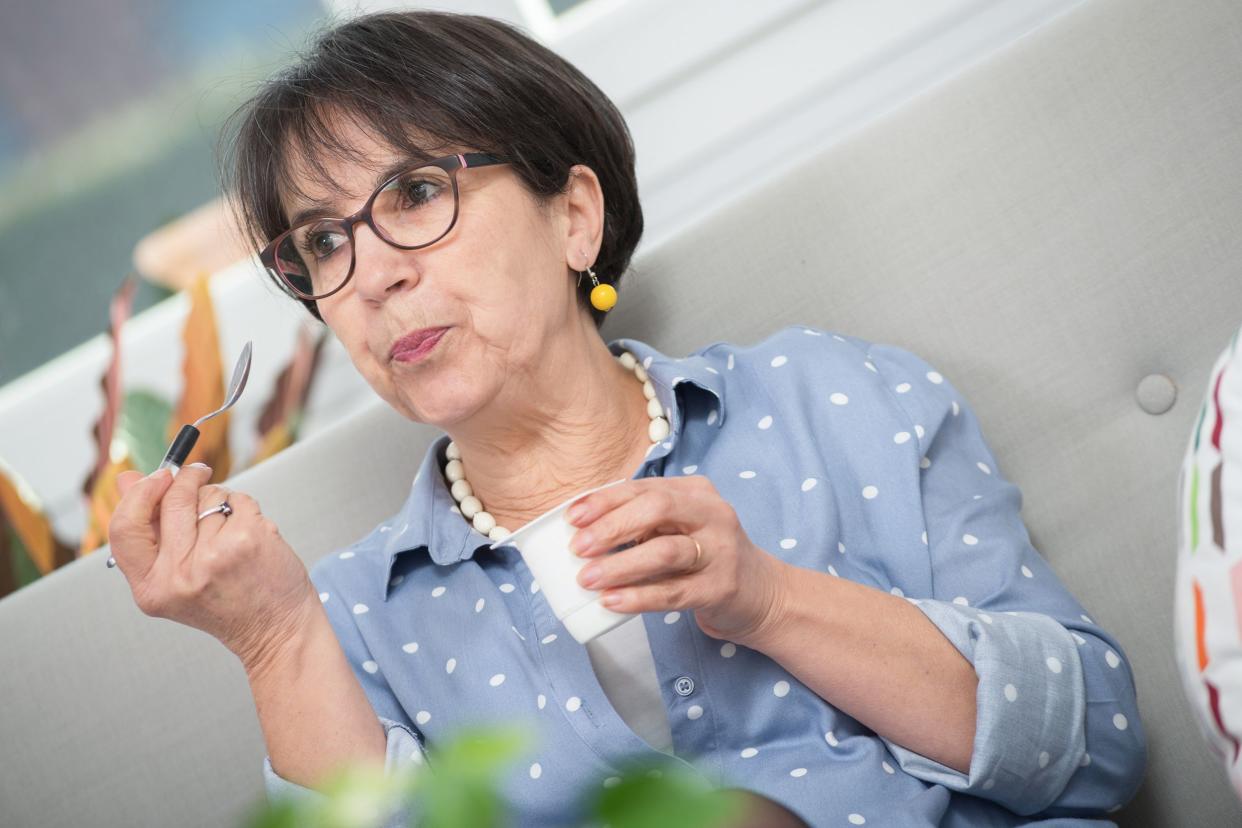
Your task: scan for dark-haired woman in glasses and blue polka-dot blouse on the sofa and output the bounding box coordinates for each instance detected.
[112,12,1145,826]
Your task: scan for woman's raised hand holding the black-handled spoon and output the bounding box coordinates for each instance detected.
[108,464,319,672]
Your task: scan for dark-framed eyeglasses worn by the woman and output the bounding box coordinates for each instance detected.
[258,153,509,299]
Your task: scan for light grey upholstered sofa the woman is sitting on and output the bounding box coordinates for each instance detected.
[0,0,1242,828]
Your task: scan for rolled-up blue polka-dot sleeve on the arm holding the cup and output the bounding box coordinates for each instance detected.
[867,345,1146,817]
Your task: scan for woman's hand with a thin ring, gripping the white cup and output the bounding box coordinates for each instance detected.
[566,475,787,644]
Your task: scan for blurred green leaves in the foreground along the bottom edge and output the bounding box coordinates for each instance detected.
[243,726,748,828]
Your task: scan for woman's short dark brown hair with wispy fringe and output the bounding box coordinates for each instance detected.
[224,11,642,328]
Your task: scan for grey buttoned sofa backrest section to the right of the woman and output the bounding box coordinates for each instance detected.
[605,0,1242,826]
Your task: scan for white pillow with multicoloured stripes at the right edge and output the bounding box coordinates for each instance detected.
[1175,322,1242,797]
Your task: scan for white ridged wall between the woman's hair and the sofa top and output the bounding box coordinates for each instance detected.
[325,0,1086,250]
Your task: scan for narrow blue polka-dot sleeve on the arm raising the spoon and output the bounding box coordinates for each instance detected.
[263,559,426,828]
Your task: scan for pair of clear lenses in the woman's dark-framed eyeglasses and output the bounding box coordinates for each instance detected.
[276,166,456,295]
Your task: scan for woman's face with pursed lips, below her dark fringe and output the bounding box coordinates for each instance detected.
[284,120,602,427]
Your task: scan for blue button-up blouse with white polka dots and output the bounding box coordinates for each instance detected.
[265,326,1146,828]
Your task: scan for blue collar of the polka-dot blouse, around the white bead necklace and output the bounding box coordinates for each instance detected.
[377,339,724,601]
